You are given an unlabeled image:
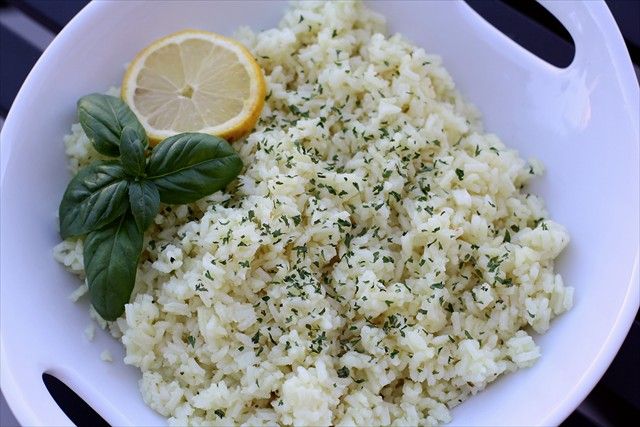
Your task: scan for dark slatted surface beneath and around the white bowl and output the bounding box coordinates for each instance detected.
[0,0,640,427]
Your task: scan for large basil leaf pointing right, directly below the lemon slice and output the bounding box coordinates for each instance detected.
[147,133,242,204]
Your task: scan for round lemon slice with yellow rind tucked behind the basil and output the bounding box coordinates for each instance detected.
[122,30,265,145]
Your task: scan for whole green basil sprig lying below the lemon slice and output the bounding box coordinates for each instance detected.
[59,94,242,320]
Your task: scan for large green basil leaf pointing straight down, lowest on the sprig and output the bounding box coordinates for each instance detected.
[84,212,143,320]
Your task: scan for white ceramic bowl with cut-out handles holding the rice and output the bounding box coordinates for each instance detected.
[0,1,639,425]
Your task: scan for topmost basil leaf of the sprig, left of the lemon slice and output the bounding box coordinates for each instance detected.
[78,93,147,157]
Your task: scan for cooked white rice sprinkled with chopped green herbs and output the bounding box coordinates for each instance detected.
[55,2,573,426]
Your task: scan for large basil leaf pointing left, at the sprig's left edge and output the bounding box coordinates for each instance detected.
[58,161,128,239]
